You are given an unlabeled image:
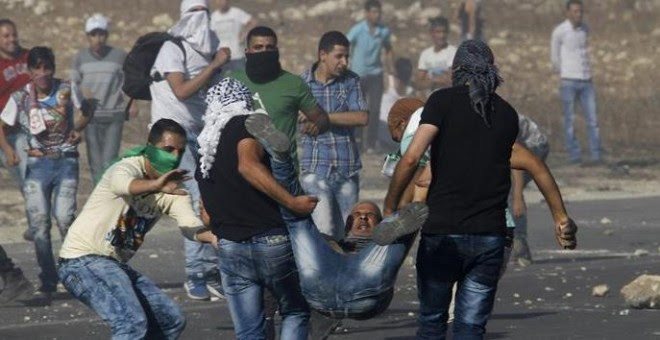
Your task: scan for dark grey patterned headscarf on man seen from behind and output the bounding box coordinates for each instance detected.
[452,40,502,127]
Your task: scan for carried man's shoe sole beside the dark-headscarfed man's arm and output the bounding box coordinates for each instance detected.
[372,202,429,246]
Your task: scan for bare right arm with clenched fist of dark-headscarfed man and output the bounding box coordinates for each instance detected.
[511,143,577,249]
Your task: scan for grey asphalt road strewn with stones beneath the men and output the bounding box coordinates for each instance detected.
[0,198,660,340]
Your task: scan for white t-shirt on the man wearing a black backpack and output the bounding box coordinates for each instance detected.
[149,41,217,134]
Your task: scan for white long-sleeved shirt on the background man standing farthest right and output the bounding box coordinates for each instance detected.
[550,19,591,80]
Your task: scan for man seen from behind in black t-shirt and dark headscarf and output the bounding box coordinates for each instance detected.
[384,40,577,339]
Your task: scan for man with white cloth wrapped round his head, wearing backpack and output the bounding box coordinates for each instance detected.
[150,0,231,300]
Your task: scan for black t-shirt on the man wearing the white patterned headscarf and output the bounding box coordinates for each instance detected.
[195,116,285,242]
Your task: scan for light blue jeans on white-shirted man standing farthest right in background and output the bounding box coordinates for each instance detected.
[559,79,601,161]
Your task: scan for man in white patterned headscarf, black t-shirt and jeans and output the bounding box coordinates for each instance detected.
[195,78,316,340]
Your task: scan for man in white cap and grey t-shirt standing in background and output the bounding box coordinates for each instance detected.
[71,13,138,182]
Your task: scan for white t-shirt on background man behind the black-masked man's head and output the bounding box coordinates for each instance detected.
[211,7,252,60]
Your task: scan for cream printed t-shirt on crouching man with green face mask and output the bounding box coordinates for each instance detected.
[60,156,202,262]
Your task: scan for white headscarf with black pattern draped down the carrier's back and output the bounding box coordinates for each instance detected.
[197,78,254,178]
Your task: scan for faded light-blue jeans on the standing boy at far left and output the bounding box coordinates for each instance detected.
[23,157,78,292]
